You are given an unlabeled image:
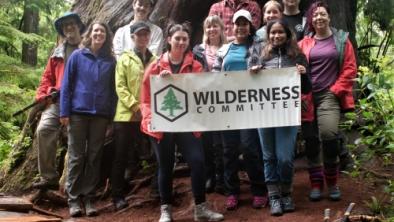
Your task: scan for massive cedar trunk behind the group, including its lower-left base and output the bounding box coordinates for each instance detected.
[0,0,357,192]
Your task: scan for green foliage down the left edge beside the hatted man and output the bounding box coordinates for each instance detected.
[0,0,69,166]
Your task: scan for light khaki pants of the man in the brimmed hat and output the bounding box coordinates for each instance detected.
[36,103,61,183]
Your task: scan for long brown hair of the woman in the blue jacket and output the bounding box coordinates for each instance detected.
[81,21,113,56]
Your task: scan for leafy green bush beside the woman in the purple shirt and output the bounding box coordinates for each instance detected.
[347,58,394,155]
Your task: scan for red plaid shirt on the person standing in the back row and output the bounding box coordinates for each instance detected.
[209,0,261,37]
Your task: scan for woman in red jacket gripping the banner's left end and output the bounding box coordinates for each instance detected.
[140,24,223,222]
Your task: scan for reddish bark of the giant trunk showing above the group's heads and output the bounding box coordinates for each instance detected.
[72,0,357,44]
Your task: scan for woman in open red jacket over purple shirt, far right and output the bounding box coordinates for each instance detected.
[299,1,357,201]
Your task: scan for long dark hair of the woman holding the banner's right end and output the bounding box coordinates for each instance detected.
[261,19,301,60]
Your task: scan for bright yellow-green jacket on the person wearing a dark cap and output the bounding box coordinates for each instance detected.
[114,51,156,122]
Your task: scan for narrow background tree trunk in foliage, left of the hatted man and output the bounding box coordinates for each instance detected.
[22,5,39,66]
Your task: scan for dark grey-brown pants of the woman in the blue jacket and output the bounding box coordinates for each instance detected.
[66,115,109,203]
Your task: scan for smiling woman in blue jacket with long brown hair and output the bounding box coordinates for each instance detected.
[60,22,116,217]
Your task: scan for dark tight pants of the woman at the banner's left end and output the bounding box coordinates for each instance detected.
[150,133,205,204]
